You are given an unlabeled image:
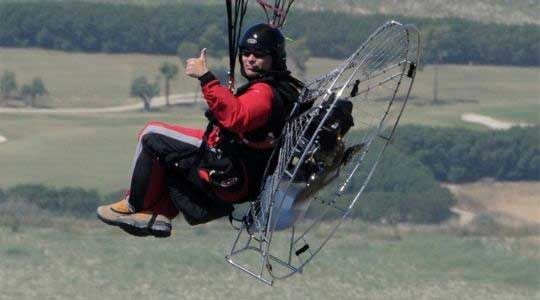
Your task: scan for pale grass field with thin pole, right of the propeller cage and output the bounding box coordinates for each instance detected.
[403,65,540,126]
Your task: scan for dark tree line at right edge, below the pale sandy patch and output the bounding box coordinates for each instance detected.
[395,126,540,183]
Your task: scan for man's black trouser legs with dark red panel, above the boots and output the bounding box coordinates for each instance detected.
[129,132,233,225]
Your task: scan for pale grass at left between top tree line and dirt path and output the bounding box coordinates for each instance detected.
[0,48,209,107]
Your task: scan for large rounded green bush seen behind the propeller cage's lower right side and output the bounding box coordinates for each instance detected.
[308,138,456,223]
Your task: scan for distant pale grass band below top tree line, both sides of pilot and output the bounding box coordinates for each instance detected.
[0,48,540,122]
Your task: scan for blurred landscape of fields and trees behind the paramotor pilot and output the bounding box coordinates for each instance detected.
[0,0,540,299]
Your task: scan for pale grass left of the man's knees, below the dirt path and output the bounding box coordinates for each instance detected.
[0,106,204,193]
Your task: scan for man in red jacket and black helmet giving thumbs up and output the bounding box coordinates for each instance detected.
[97,24,302,237]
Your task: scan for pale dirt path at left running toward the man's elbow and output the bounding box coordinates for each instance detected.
[0,93,201,115]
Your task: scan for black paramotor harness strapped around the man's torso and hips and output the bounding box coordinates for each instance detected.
[199,77,298,203]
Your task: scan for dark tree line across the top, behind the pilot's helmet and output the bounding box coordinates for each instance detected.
[0,2,540,66]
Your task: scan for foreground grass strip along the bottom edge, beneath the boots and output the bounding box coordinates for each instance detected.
[0,220,540,300]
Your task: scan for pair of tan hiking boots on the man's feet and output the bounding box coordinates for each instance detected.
[97,199,171,237]
